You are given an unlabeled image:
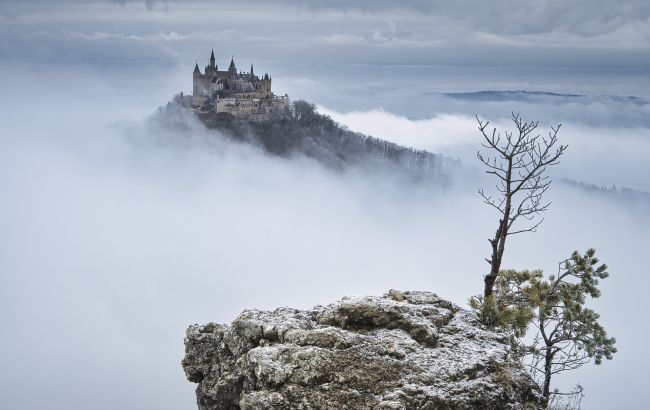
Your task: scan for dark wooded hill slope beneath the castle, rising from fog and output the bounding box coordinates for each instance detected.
[162,101,461,183]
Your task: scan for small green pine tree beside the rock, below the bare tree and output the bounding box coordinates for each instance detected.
[470,249,617,403]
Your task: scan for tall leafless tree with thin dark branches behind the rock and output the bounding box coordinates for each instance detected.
[476,113,567,298]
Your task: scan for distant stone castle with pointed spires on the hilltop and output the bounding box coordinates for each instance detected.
[183,50,289,120]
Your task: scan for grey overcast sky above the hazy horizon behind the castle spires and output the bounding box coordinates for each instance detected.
[0,0,650,71]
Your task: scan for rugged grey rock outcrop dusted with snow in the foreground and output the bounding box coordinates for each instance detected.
[183,290,539,410]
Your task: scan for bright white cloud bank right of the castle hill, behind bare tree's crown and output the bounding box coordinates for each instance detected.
[321,97,650,191]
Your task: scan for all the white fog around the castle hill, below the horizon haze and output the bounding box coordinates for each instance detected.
[0,56,650,409]
